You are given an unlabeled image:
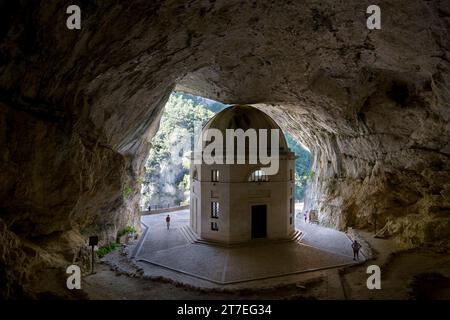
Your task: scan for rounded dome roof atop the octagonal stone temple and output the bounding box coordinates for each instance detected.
[203,105,289,151]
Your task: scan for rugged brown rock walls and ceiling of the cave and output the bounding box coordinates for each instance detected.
[0,0,450,298]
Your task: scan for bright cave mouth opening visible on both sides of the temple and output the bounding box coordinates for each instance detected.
[140,90,312,213]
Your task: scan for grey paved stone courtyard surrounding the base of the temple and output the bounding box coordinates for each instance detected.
[135,210,363,284]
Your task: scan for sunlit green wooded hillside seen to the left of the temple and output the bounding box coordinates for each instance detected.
[141,92,217,208]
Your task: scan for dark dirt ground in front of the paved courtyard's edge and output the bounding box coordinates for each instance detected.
[83,228,450,300]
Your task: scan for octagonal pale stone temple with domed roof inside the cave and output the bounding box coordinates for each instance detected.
[190,105,295,244]
